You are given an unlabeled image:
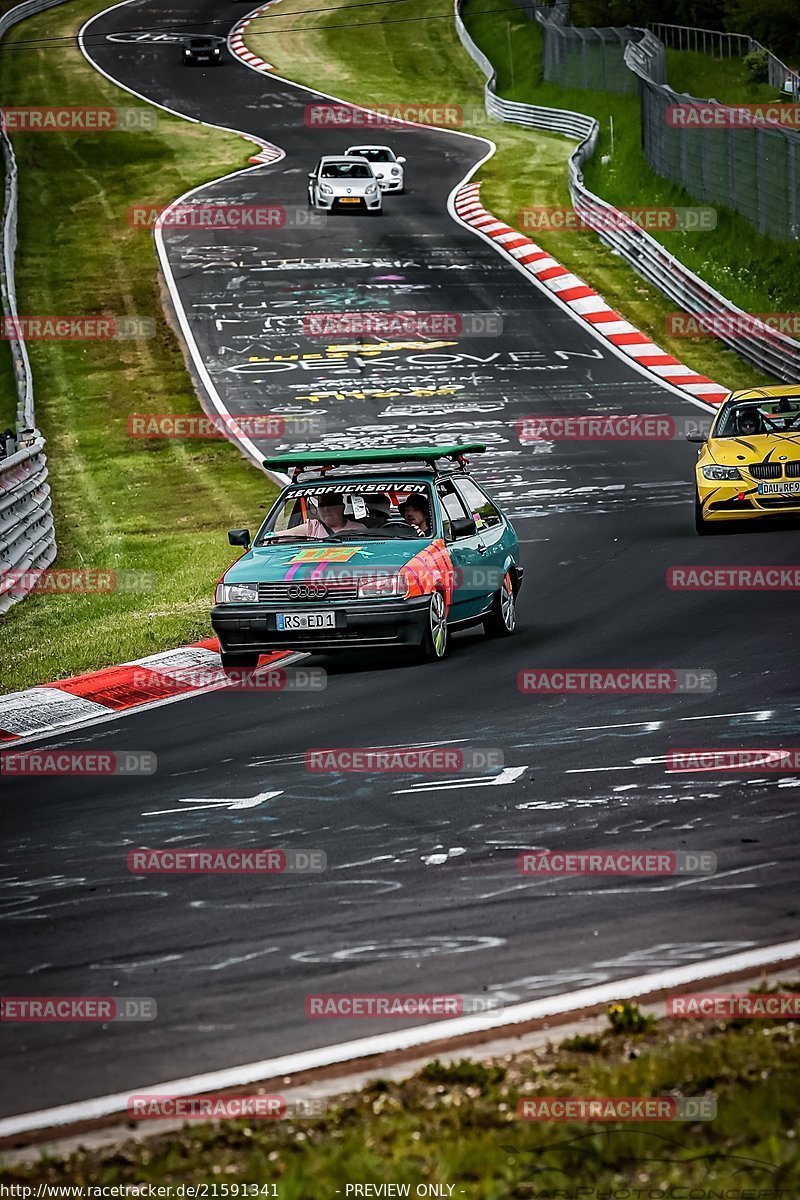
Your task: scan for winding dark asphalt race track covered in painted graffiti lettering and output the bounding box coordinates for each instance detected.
[1,0,800,1115]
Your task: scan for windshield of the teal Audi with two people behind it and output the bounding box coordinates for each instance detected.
[255,479,434,546]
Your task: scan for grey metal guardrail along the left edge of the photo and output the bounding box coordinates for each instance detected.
[0,0,62,616]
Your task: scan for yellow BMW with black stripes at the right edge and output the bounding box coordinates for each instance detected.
[687,384,800,534]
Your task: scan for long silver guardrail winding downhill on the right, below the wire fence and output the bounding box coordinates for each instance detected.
[453,0,800,383]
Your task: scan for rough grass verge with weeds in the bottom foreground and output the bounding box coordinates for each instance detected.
[4,1003,800,1200]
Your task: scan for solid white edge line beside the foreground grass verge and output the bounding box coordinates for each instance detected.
[0,940,800,1138]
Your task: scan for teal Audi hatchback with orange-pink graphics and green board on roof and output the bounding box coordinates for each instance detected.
[211,443,523,670]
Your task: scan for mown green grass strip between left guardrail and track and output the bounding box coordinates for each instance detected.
[0,0,280,691]
